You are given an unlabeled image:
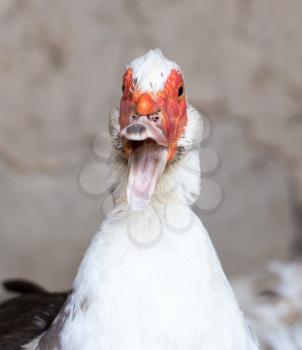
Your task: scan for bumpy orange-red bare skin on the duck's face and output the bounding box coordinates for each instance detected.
[119,68,187,160]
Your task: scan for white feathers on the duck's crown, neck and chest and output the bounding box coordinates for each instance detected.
[27,50,258,350]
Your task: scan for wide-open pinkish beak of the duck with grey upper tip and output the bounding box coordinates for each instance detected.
[120,116,168,211]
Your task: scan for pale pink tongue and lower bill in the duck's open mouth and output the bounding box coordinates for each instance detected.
[127,142,168,211]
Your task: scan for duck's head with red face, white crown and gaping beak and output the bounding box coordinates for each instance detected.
[111,49,201,210]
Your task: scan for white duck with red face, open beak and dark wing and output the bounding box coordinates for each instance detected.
[0,49,259,350]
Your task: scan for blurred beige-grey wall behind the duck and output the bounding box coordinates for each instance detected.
[0,0,302,290]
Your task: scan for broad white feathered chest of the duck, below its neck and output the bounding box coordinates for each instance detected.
[36,204,256,350]
